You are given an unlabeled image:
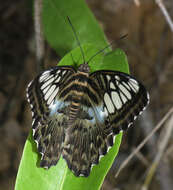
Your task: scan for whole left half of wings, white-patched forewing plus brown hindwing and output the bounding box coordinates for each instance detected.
[27,66,75,168]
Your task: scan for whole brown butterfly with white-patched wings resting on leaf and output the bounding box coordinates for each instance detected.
[27,56,149,177]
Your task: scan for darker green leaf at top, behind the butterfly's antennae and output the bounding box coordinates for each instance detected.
[43,0,107,56]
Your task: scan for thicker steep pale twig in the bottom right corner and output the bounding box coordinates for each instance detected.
[142,115,173,190]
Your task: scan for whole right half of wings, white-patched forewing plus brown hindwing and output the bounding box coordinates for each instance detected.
[62,71,149,177]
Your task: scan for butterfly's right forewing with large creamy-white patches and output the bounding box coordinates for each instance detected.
[90,71,149,134]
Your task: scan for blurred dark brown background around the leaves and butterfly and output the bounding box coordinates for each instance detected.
[0,0,173,190]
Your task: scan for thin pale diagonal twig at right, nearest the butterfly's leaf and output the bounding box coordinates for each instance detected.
[115,107,173,177]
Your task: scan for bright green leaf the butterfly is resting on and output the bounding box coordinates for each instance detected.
[16,44,128,190]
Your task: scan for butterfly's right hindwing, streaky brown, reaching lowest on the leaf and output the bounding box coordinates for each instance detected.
[62,108,113,177]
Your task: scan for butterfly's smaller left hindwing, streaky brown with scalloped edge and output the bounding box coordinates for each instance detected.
[33,115,65,168]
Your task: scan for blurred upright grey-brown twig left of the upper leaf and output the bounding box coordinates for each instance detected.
[34,0,44,72]
